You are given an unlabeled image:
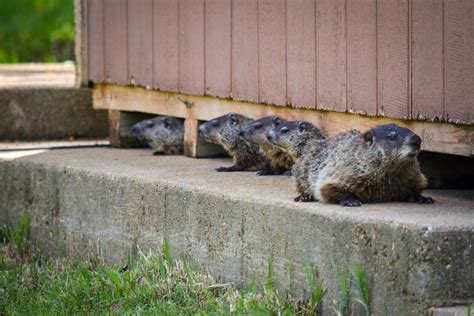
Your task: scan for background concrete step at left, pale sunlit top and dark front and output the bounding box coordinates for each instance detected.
[0,64,108,141]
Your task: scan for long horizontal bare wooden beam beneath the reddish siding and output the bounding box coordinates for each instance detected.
[93,84,474,156]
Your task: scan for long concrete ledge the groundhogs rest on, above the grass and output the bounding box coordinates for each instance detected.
[0,148,474,315]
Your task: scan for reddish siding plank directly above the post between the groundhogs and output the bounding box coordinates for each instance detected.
[179,0,205,95]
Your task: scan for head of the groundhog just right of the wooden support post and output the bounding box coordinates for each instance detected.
[199,112,252,144]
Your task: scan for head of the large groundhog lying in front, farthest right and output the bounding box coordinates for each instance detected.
[362,124,421,161]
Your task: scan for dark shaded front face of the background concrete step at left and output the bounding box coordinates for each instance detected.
[0,87,108,140]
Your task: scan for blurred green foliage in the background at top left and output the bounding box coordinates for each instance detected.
[0,0,74,63]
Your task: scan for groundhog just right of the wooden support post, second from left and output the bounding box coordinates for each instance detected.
[199,113,270,172]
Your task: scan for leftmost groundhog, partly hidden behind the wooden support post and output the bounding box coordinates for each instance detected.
[132,116,184,155]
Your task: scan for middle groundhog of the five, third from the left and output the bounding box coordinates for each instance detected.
[240,116,294,176]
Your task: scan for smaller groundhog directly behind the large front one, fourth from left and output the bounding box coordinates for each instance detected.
[266,121,327,202]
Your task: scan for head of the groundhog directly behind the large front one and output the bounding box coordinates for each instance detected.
[266,121,325,154]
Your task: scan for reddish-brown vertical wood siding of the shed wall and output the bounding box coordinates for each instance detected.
[87,0,474,123]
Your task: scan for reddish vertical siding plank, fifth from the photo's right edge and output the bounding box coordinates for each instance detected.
[316,0,347,111]
